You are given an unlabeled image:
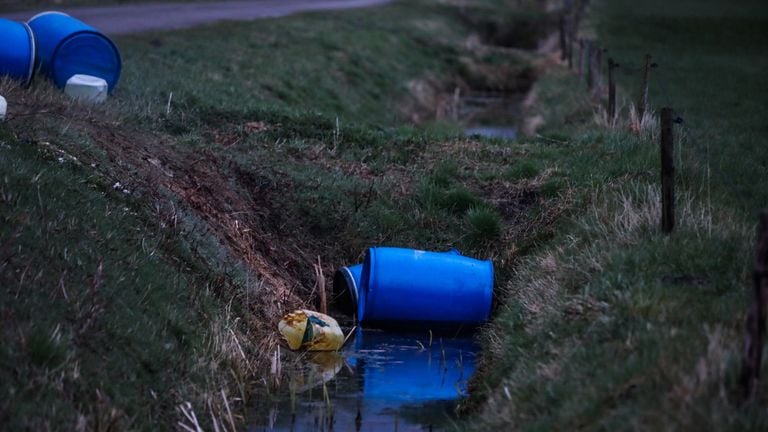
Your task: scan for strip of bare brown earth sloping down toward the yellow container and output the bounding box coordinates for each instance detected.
[101,128,312,310]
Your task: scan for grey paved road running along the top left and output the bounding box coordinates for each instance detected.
[0,0,392,35]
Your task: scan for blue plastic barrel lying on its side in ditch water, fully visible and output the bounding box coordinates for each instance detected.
[357,247,493,325]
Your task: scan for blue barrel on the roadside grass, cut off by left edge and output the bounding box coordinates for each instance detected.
[0,18,35,85]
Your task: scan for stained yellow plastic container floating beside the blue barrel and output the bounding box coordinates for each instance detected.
[277,310,344,351]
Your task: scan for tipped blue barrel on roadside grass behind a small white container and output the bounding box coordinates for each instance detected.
[29,12,122,92]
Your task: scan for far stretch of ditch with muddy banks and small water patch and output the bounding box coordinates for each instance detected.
[401,8,557,139]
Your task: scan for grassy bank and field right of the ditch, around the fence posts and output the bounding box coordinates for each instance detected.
[474,1,768,430]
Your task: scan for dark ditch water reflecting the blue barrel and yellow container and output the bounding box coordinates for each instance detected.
[249,330,478,431]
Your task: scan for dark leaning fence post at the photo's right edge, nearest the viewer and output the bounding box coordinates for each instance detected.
[740,211,768,400]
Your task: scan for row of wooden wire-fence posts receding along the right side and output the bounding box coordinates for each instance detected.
[559,0,768,401]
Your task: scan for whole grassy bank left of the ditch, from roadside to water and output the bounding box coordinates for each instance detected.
[0,1,564,429]
